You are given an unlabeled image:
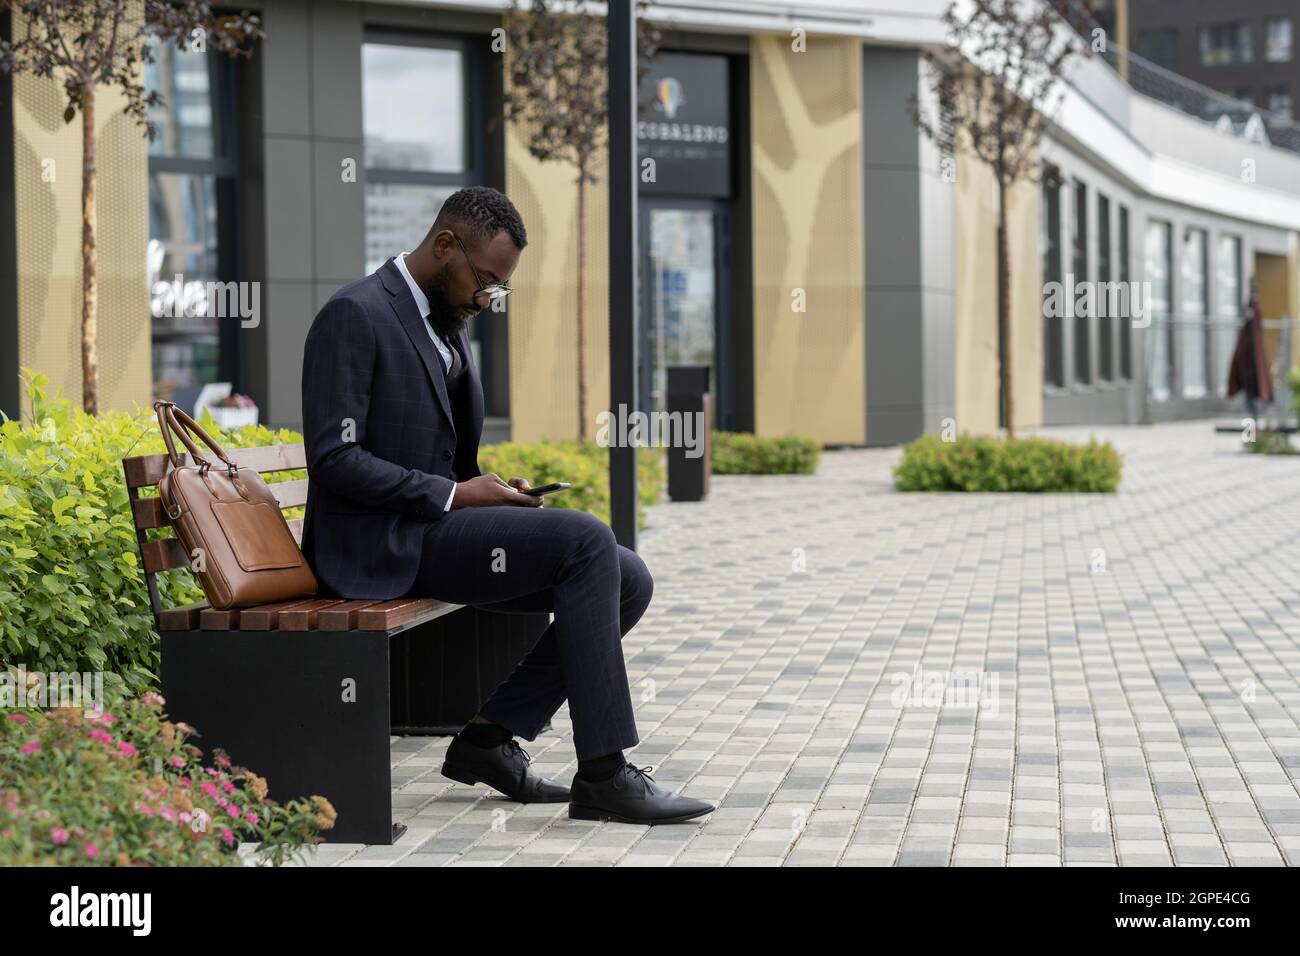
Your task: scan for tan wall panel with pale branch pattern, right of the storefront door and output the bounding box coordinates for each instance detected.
[750,35,866,444]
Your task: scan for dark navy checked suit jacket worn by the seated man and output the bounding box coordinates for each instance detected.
[303,259,484,598]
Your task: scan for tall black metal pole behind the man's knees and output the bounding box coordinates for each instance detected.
[606,0,637,550]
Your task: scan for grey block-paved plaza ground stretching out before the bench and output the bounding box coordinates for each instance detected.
[242,421,1300,866]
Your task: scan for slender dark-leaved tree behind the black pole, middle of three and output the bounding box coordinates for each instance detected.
[504,0,659,438]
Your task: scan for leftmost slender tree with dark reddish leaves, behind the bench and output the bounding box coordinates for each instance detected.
[0,0,264,415]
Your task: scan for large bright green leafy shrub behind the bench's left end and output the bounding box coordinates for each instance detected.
[0,373,302,693]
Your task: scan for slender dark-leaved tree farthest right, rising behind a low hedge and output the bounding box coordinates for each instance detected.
[914,0,1089,436]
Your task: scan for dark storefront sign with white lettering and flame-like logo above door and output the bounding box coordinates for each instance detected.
[637,53,731,198]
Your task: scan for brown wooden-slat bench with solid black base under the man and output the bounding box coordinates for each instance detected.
[122,445,470,844]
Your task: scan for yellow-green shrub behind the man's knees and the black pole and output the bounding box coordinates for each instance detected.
[478,440,664,527]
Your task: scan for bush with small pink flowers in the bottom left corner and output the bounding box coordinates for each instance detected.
[0,692,335,866]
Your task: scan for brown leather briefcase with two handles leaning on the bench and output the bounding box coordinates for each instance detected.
[153,402,317,610]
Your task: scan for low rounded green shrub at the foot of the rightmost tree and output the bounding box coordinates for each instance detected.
[893,434,1122,492]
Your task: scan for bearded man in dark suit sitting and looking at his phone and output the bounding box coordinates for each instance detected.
[303,186,714,823]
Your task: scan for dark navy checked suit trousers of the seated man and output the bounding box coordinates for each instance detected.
[411,505,654,760]
